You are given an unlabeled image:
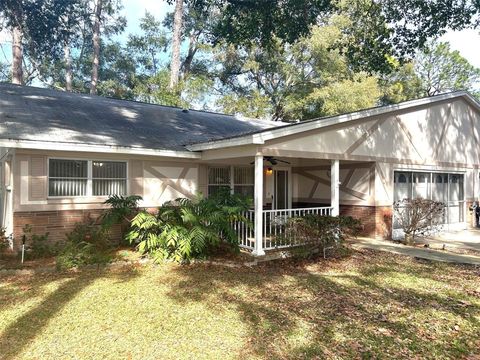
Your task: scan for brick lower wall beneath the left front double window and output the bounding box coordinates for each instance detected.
[13,210,121,249]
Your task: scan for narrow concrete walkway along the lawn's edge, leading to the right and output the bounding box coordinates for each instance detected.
[351,238,480,265]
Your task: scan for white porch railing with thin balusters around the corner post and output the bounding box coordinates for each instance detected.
[233,206,333,250]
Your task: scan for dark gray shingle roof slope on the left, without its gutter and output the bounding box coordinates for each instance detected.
[0,84,280,150]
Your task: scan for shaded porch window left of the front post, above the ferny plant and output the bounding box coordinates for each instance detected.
[208,166,254,198]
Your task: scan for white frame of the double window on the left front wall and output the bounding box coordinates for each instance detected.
[46,156,130,199]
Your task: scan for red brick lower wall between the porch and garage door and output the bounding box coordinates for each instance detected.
[340,205,392,239]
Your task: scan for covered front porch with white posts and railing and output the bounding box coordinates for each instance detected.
[201,154,375,256]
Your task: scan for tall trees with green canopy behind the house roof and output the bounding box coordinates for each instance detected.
[0,0,480,121]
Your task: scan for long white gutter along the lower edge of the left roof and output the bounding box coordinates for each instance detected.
[0,139,200,159]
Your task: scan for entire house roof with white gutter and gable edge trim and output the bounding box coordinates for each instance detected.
[0,83,480,158]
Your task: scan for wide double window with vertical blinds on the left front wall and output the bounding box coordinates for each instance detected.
[48,159,127,196]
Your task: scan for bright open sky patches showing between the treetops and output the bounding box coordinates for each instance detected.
[0,0,480,79]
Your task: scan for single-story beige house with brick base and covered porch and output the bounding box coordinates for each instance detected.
[0,84,480,255]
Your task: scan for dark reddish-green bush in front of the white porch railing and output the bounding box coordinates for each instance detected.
[285,215,362,257]
